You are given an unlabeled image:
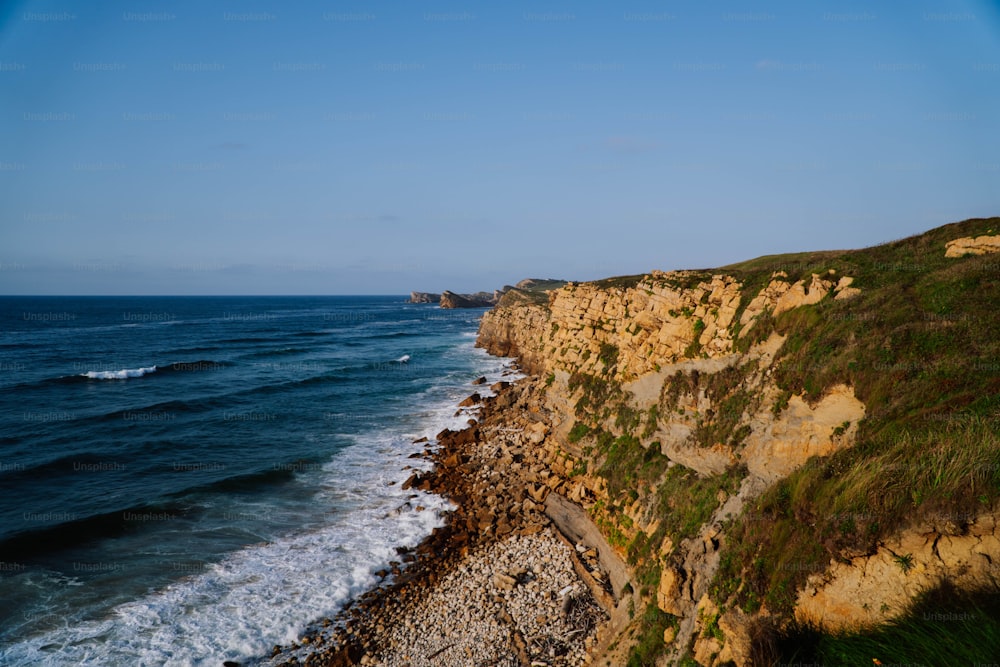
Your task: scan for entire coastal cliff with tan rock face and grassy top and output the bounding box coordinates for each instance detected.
[478,218,1000,665]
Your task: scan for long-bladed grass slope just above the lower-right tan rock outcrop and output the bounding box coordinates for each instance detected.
[712,416,1000,613]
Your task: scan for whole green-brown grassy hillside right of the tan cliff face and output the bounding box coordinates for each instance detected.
[715,218,1000,612]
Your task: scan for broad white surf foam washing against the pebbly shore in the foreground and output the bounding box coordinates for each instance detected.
[0,439,450,666]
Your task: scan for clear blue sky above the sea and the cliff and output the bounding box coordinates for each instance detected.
[0,0,1000,294]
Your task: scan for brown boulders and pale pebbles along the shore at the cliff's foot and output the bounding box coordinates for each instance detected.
[262,378,624,667]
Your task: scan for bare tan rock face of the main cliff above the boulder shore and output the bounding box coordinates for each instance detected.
[478,271,865,664]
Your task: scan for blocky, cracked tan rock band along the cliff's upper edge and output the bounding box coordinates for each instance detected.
[479,271,857,381]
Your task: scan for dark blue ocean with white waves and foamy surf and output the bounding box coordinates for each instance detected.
[0,296,510,666]
